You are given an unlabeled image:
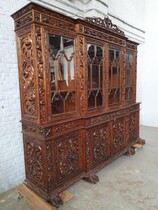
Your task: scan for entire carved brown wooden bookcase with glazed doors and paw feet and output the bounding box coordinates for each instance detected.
[12,3,144,207]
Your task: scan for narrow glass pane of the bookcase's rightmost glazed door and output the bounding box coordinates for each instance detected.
[125,52,133,100]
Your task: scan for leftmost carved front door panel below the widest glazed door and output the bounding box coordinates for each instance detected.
[54,133,82,183]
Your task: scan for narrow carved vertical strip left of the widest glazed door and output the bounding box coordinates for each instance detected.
[35,26,46,122]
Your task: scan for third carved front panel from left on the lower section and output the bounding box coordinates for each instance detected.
[111,118,125,153]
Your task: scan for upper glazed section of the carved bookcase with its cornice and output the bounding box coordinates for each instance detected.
[12,3,137,124]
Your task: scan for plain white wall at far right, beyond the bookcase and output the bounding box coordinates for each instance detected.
[142,0,158,127]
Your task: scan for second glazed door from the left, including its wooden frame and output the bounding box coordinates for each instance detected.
[86,40,105,113]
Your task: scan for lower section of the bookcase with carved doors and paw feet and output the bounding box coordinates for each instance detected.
[23,105,139,205]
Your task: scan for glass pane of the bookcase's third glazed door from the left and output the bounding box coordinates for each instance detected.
[109,48,120,105]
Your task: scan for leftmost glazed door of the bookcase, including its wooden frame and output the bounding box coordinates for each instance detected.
[46,31,78,118]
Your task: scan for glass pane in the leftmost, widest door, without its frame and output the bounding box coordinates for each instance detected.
[49,35,75,114]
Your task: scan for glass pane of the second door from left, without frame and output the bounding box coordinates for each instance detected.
[87,44,103,108]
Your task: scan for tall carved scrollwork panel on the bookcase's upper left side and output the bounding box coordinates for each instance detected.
[20,33,37,118]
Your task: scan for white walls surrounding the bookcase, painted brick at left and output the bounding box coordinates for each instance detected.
[0,0,154,192]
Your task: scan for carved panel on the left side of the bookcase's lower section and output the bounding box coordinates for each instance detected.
[24,137,44,186]
